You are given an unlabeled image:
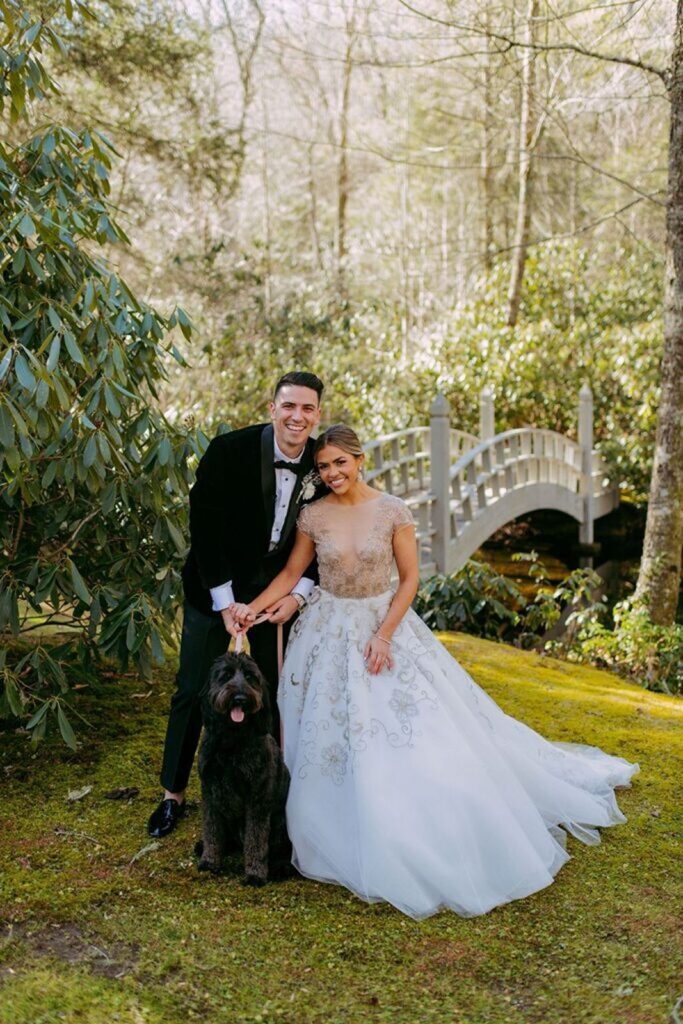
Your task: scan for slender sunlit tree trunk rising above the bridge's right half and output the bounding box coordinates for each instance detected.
[508,0,539,327]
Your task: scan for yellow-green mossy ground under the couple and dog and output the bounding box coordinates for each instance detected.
[0,635,683,1024]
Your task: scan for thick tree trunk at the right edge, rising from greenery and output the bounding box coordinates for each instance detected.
[636,0,683,626]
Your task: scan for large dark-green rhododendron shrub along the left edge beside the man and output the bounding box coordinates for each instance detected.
[0,0,198,745]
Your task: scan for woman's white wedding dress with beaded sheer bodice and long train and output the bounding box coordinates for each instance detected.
[279,493,638,919]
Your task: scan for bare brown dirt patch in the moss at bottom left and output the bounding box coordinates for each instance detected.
[0,924,138,978]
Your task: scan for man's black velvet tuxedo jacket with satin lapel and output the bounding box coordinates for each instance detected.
[182,424,325,614]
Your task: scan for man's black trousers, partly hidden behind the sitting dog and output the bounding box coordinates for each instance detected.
[161,602,293,793]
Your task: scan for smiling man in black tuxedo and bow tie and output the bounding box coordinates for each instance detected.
[147,373,323,839]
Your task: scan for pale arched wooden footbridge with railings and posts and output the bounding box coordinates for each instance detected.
[365,385,618,577]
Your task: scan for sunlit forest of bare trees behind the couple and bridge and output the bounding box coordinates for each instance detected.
[60,0,675,485]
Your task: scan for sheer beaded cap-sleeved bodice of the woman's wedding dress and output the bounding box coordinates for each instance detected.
[297,492,415,597]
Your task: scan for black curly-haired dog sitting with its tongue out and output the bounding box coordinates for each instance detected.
[198,654,292,886]
